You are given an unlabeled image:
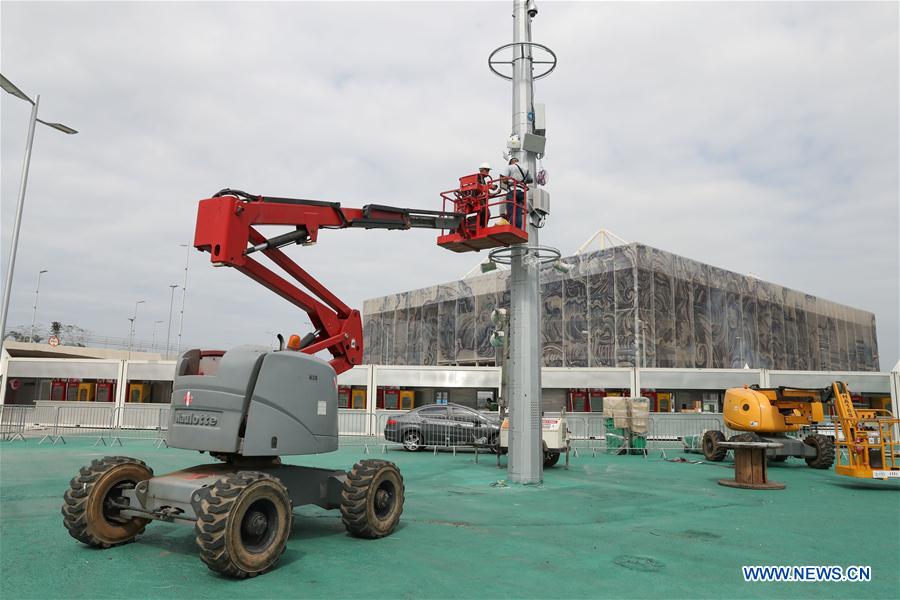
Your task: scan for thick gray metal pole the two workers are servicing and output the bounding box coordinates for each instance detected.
[507,0,544,484]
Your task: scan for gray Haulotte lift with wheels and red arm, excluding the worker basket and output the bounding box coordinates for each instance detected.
[62,189,477,577]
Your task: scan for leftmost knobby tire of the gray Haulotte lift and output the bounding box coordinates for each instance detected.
[62,456,153,548]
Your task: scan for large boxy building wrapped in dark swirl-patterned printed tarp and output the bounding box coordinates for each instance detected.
[363,243,879,371]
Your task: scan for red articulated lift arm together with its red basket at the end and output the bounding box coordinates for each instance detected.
[194,183,528,374]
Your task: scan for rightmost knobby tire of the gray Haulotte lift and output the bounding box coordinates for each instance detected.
[341,459,405,539]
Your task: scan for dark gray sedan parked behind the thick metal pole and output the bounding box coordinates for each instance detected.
[384,403,500,452]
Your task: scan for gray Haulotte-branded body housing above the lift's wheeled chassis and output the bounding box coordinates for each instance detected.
[166,346,338,457]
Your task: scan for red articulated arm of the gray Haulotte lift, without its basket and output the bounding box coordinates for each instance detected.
[194,189,465,374]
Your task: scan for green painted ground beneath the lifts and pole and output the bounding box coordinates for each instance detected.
[0,440,900,598]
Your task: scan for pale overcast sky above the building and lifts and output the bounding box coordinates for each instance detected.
[0,1,900,370]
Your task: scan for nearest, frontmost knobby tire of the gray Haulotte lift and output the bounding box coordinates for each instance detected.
[194,471,293,578]
